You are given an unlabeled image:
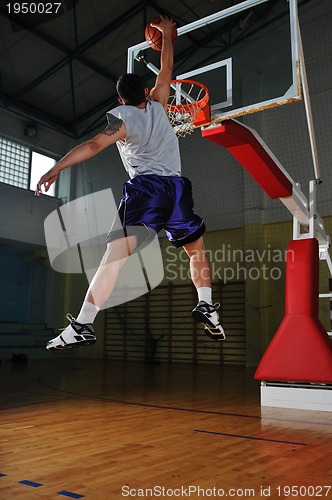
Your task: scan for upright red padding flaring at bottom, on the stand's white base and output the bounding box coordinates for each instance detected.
[255,239,332,384]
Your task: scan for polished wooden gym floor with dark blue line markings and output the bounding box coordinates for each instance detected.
[0,353,332,500]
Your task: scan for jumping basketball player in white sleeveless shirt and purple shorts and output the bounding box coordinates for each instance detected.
[36,16,225,349]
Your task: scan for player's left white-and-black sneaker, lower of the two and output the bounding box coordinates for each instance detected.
[46,313,97,350]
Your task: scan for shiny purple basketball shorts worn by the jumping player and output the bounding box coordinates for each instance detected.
[107,175,205,247]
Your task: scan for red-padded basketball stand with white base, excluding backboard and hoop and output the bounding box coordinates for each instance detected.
[172,19,332,411]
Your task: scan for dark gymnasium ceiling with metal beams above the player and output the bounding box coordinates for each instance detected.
[0,0,314,139]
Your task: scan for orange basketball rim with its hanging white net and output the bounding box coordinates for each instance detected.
[167,80,209,137]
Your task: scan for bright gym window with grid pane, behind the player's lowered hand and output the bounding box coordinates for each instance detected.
[0,137,55,196]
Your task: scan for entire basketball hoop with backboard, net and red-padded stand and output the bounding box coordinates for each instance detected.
[128,0,332,411]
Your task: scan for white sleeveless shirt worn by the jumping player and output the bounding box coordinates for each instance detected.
[106,101,181,178]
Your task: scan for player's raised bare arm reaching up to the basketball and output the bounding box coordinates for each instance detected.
[150,16,175,108]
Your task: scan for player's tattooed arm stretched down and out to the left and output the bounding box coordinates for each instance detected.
[35,117,126,196]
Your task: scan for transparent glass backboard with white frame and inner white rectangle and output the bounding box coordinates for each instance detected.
[127,0,301,126]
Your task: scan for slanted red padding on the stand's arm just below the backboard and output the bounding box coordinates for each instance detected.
[202,120,293,198]
